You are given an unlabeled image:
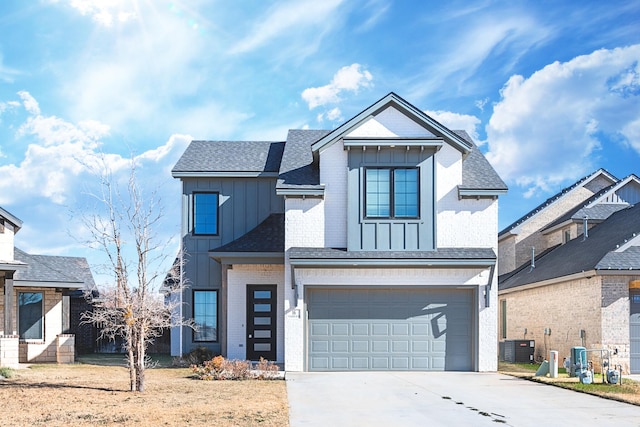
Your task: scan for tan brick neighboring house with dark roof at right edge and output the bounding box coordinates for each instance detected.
[499,170,640,373]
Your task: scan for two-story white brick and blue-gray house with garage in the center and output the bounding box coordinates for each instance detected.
[172,93,507,371]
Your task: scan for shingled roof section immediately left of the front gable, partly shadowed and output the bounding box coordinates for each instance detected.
[277,129,330,189]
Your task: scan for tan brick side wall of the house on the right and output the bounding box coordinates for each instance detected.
[499,276,638,373]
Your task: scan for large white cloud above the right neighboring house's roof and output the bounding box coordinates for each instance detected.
[486,45,640,194]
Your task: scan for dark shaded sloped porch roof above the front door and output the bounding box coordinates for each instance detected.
[209,214,284,254]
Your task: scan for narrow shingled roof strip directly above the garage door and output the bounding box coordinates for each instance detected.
[289,247,496,261]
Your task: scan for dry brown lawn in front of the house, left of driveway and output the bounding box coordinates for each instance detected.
[0,364,289,427]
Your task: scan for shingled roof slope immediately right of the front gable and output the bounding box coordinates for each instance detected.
[454,130,507,190]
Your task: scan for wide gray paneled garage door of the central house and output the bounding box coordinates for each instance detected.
[305,288,474,371]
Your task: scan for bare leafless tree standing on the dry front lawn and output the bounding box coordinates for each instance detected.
[81,159,192,392]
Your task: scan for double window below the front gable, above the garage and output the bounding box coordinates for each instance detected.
[365,168,420,218]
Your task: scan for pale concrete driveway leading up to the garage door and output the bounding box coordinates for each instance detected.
[286,372,640,427]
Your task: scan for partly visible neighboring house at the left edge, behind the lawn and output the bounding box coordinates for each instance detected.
[0,208,94,366]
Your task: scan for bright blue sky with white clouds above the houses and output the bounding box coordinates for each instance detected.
[0,0,640,288]
